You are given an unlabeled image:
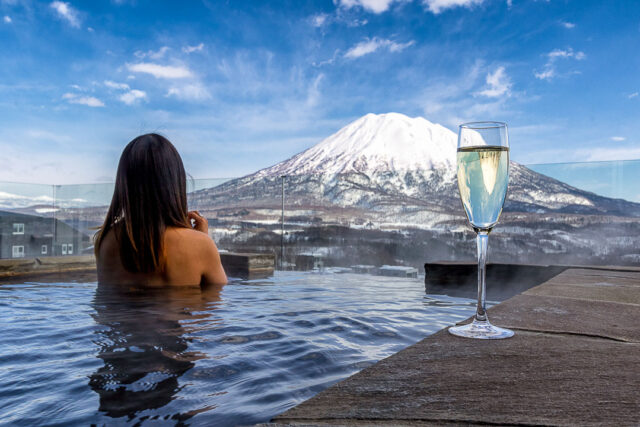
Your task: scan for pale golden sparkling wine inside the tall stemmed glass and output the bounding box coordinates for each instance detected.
[458,145,509,231]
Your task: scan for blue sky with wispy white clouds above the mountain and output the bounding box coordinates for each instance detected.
[0,0,640,184]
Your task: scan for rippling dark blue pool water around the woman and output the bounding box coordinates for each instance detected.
[0,272,475,426]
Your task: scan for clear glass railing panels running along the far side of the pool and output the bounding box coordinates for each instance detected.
[0,161,640,275]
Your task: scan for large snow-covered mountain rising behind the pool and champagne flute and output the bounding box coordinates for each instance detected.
[192,113,640,224]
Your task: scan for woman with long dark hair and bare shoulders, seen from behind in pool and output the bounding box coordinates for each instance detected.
[95,133,227,287]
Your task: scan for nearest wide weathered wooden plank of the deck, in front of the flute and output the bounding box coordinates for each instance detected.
[273,331,640,425]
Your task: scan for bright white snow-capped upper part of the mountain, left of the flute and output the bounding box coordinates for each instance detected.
[252,113,457,176]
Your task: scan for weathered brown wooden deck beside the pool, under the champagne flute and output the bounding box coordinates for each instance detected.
[270,268,640,426]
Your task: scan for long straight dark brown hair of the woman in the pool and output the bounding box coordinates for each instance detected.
[95,133,189,273]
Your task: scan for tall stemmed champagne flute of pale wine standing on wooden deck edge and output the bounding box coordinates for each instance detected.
[449,122,513,339]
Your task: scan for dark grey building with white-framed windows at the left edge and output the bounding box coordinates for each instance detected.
[0,211,91,258]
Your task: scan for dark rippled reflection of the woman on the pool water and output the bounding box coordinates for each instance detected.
[89,285,220,419]
